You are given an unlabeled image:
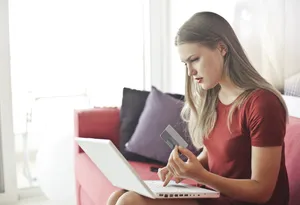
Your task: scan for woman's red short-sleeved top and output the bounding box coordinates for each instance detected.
[200,89,289,205]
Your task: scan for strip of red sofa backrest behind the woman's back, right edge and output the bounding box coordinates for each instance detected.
[285,117,300,205]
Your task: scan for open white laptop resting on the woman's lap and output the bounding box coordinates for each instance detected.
[75,137,220,199]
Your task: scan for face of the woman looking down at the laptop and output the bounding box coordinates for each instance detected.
[178,43,226,90]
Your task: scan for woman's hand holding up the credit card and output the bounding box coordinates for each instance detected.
[164,146,206,186]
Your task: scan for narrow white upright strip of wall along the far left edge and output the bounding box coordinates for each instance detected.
[0,0,17,204]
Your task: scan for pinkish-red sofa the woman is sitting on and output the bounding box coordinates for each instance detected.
[75,108,300,205]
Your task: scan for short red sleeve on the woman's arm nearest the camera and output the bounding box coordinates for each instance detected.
[248,91,286,147]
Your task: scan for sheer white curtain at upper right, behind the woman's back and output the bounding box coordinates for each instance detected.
[233,0,300,96]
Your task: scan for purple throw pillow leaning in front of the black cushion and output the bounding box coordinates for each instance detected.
[125,86,199,163]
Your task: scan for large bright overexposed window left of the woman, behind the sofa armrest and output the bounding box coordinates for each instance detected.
[9,0,148,188]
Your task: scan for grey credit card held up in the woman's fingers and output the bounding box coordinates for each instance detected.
[160,125,188,150]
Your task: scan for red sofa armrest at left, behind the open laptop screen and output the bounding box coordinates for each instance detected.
[74,107,120,153]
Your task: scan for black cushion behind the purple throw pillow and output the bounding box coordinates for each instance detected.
[119,87,184,163]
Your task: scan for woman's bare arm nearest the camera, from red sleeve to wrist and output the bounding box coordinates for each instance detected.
[196,146,282,203]
